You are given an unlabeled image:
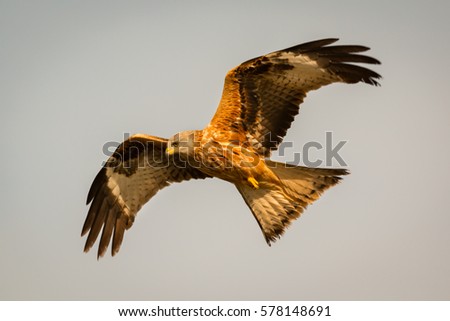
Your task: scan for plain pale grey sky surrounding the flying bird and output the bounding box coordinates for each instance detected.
[0,0,450,300]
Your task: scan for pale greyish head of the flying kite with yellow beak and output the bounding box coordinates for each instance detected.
[166,130,201,160]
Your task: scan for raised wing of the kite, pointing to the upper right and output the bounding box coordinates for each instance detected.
[206,39,381,156]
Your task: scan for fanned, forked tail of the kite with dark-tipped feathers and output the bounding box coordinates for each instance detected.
[236,161,348,245]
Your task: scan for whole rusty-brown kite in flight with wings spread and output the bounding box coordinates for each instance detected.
[81,39,381,258]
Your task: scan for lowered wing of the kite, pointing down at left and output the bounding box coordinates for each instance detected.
[81,135,208,257]
